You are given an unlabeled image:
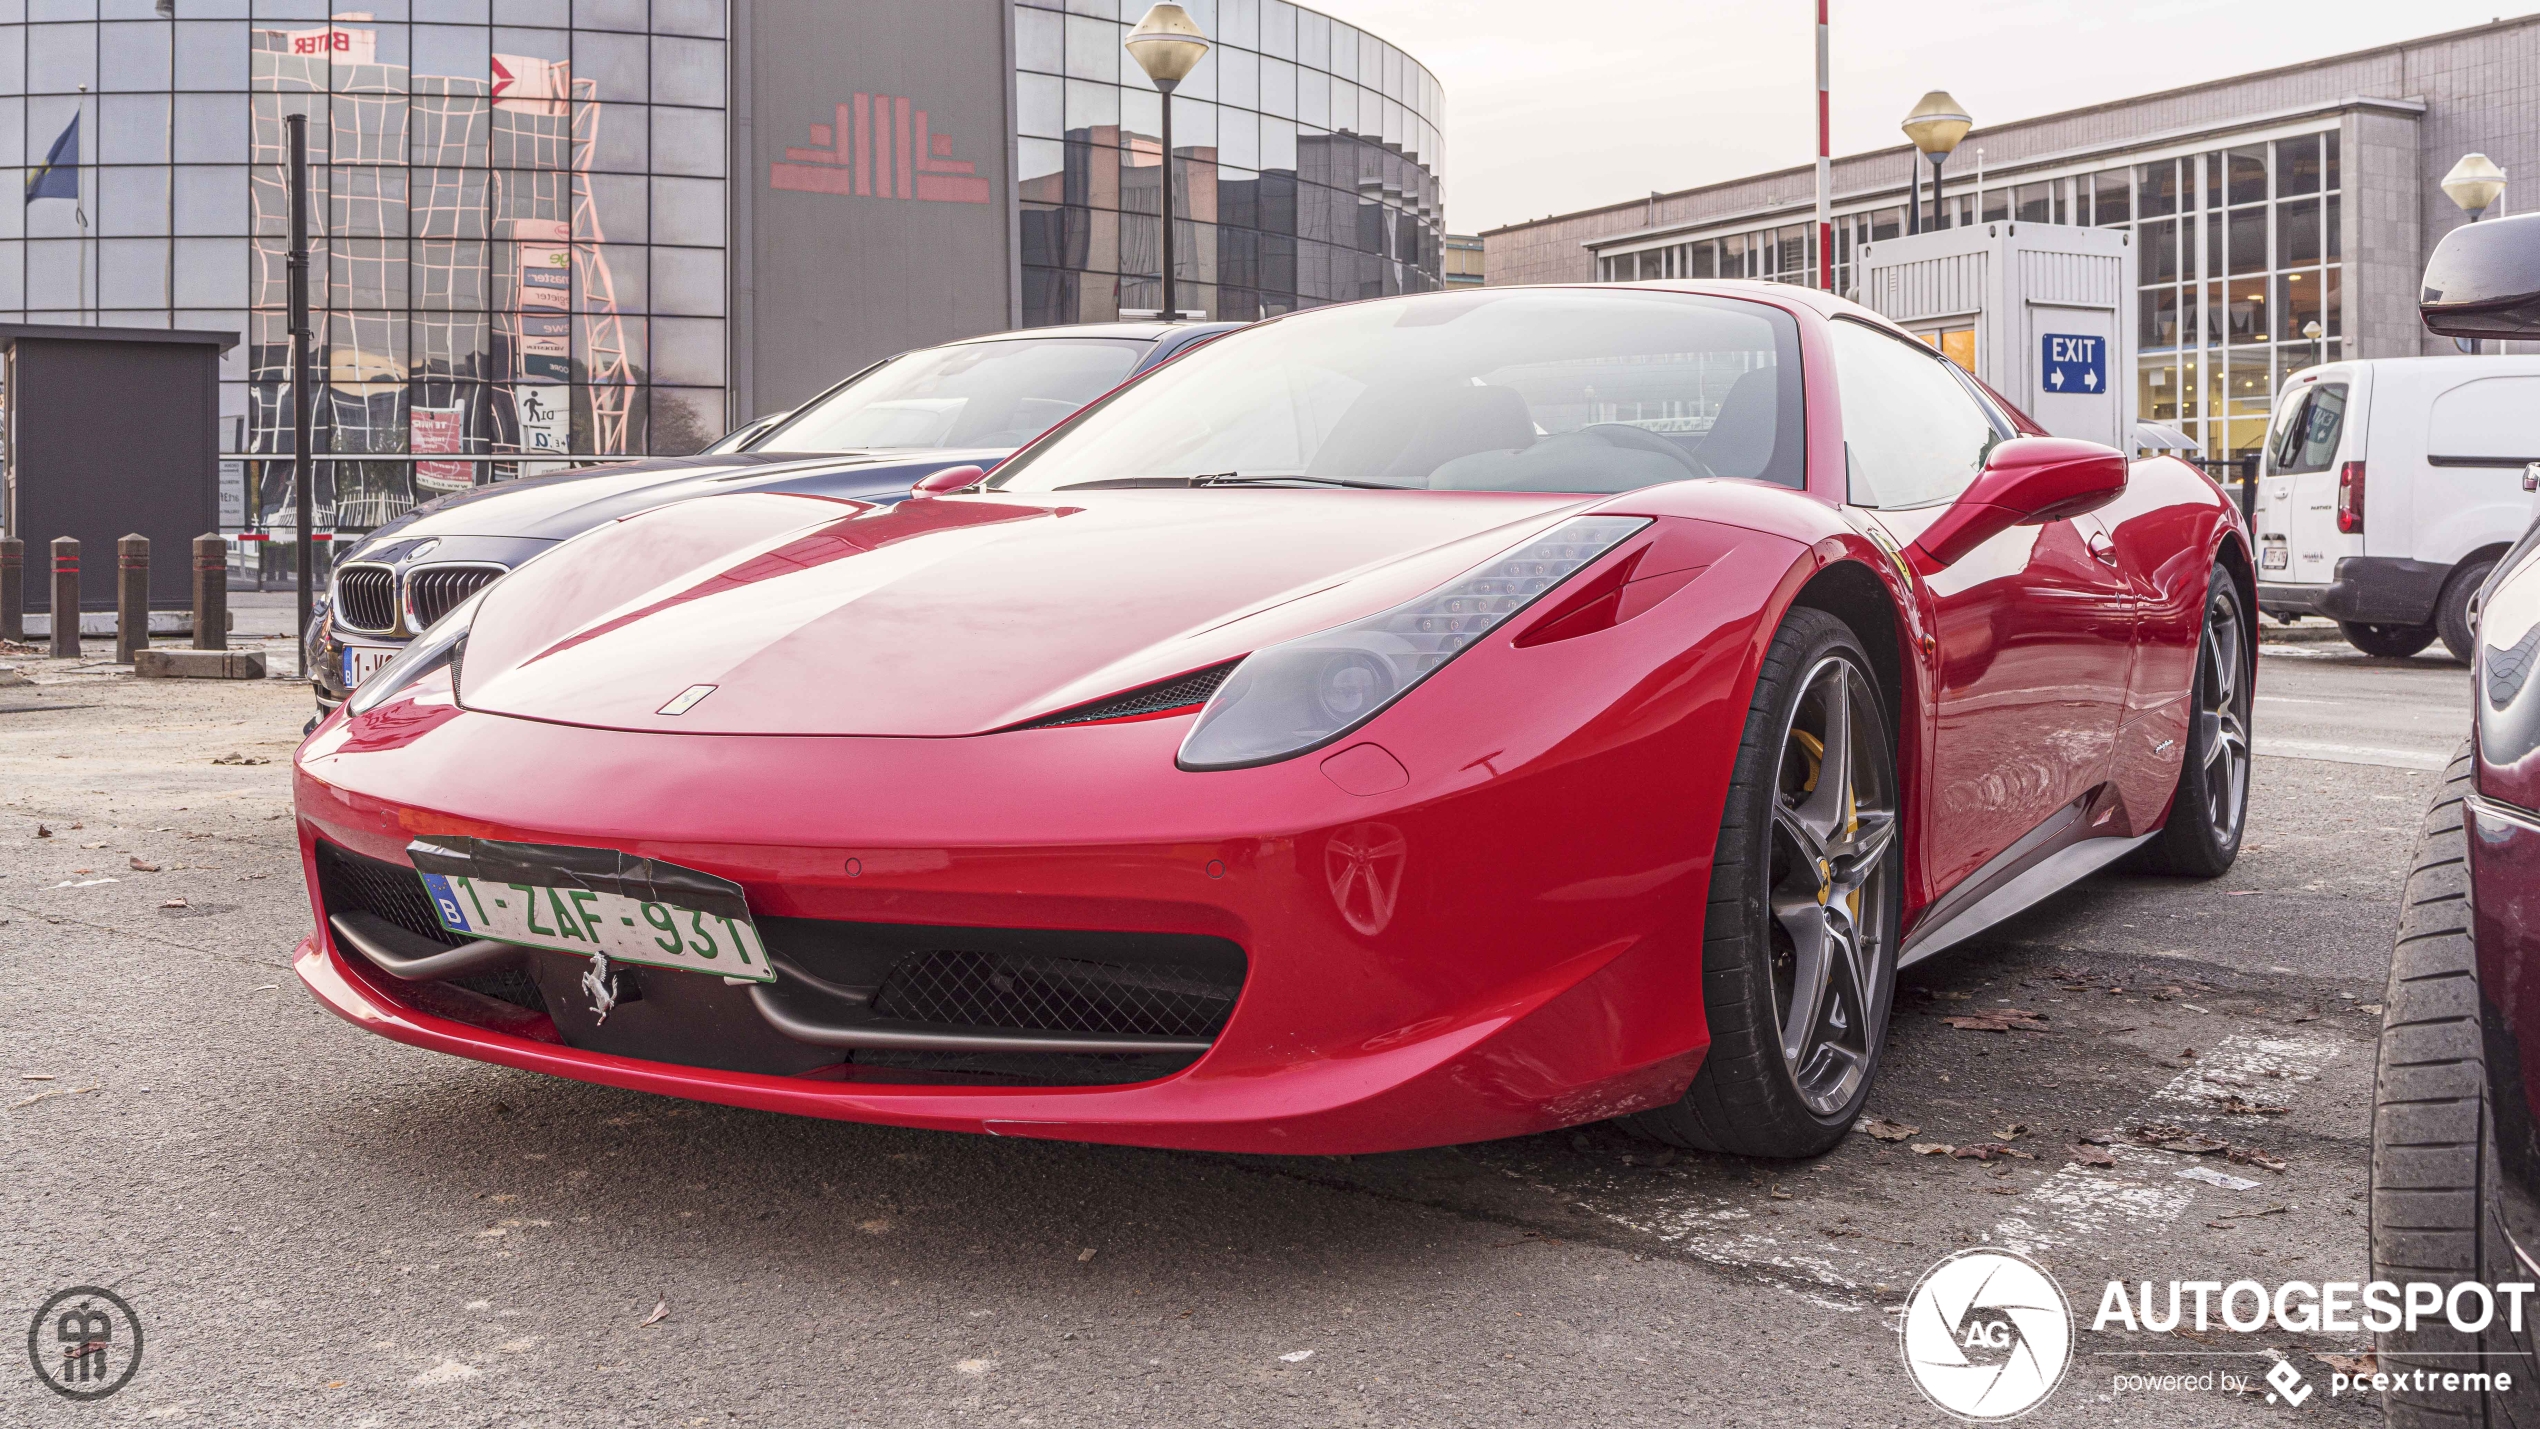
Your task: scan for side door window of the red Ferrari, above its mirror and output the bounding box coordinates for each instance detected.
[1829,322,2002,508]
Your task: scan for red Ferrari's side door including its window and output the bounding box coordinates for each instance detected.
[1831,322,2134,896]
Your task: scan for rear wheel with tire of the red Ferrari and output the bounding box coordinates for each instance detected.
[2144,566,2253,878]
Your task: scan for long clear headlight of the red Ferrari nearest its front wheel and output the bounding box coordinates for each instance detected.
[1176,515,1648,769]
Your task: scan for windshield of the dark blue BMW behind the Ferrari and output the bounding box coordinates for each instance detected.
[749,338,1151,452]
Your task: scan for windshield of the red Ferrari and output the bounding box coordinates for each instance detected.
[988,287,1806,492]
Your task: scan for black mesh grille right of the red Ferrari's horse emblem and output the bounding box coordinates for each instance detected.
[874,949,1242,1038]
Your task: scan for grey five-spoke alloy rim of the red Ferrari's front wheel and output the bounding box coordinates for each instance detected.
[1768,655,1897,1117]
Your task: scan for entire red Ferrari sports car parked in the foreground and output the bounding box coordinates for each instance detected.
[297,282,2253,1155]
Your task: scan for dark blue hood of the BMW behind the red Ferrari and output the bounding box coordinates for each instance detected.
[345,447,1013,550]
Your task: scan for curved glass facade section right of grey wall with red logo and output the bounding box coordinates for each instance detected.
[1013,0,1443,327]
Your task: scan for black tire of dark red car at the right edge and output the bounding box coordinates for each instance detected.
[2372,746,2540,1429]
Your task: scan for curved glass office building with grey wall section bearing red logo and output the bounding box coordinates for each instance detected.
[0,0,1443,550]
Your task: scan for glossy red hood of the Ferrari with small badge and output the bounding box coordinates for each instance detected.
[460,487,1600,736]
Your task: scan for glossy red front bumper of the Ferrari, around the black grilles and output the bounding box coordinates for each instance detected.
[297,642,1742,1155]
